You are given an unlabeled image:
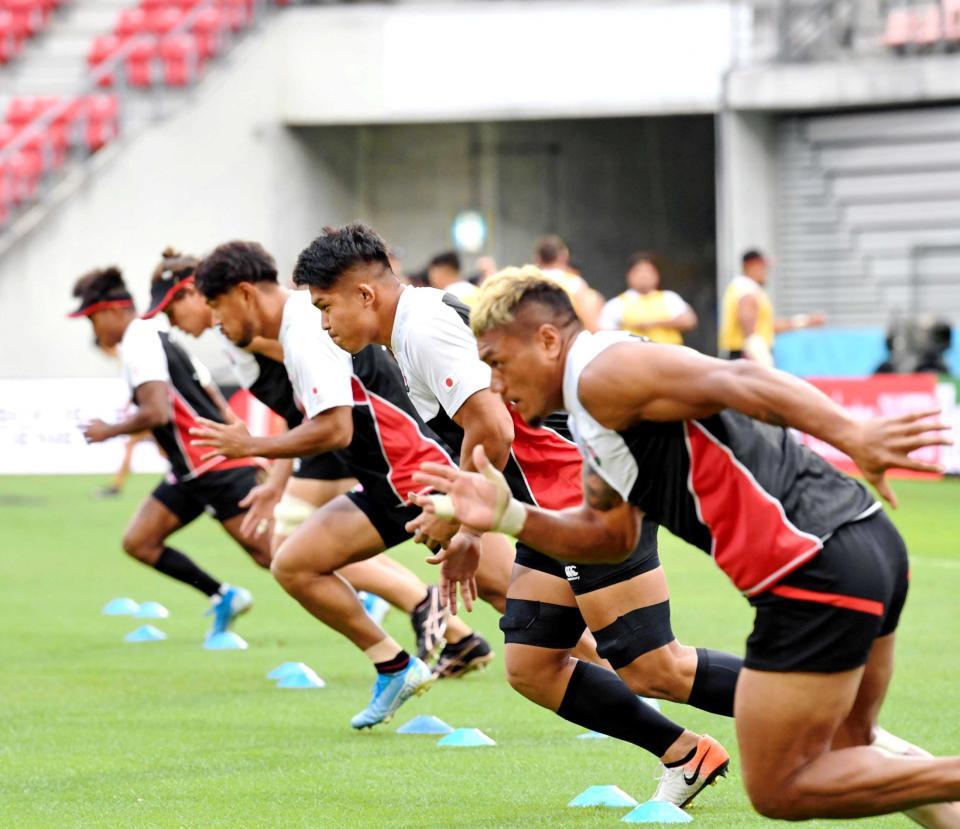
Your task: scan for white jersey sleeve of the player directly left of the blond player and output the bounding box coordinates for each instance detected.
[406,312,490,417]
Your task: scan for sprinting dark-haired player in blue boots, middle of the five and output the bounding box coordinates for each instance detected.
[187,242,492,728]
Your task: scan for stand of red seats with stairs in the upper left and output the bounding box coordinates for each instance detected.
[0,0,270,228]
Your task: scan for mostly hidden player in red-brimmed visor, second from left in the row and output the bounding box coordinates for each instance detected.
[144,249,452,659]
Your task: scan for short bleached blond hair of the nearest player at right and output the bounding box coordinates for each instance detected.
[470,265,576,337]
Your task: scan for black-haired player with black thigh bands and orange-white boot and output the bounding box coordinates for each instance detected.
[294,224,740,806]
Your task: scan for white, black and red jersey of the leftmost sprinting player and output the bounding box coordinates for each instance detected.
[120,319,253,481]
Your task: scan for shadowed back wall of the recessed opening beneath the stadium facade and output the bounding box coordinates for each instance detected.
[318,116,716,350]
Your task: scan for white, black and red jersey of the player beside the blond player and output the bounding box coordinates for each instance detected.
[391,287,583,509]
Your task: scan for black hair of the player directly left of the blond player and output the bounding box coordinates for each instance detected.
[293,222,390,289]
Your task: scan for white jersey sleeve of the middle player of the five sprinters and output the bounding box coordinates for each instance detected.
[284,314,353,420]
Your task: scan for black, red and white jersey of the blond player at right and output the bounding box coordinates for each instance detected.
[563,331,880,596]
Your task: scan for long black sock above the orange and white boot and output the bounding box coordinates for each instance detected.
[557,661,684,757]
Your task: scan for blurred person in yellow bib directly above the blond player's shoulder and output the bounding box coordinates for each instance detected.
[600,252,697,345]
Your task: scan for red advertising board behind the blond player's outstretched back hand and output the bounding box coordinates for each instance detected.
[799,374,943,478]
